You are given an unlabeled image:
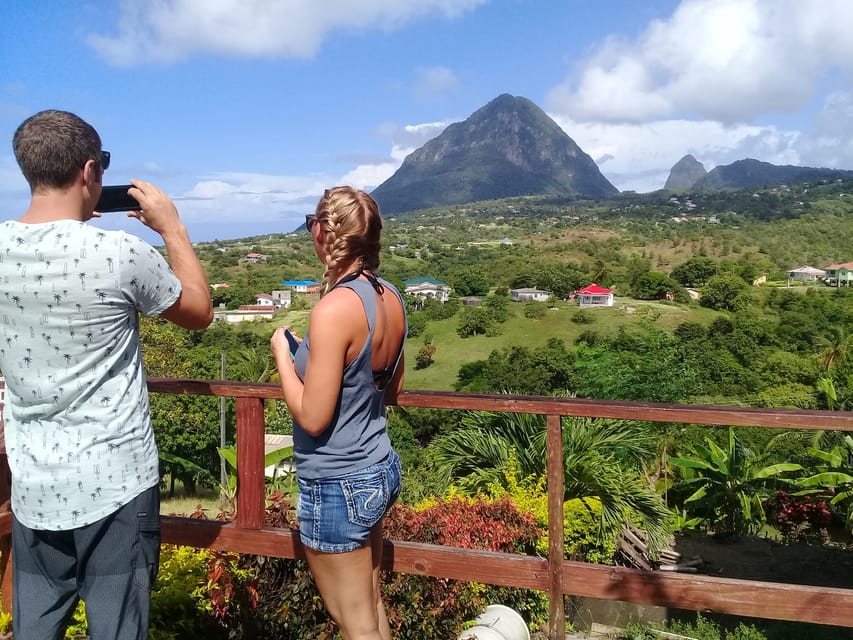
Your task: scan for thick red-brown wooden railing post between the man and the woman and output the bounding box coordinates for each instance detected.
[237,398,266,529]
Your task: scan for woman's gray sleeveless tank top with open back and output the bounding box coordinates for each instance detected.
[293,278,405,480]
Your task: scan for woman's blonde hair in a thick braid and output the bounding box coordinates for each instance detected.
[315,187,382,293]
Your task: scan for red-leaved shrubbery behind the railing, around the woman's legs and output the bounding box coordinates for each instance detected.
[201,494,548,640]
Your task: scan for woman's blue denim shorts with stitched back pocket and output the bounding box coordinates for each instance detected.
[296,450,402,553]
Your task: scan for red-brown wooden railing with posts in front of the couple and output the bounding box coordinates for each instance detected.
[5,378,853,640]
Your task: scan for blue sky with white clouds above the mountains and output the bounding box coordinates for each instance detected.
[0,0,853,241]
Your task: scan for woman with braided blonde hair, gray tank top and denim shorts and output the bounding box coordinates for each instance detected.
[271,187,406,640]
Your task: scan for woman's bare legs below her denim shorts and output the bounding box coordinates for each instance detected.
[305,525,391,640]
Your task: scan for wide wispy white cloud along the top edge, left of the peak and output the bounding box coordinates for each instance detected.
[89,0,489,66]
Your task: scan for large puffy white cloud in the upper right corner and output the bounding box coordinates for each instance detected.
[547,0,853,123]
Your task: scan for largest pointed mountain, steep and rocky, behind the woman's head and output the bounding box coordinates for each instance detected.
[371,94,618,213]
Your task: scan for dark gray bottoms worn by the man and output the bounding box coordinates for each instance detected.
[12,486,160,640]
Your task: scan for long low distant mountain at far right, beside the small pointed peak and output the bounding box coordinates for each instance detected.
[694,158,853,191]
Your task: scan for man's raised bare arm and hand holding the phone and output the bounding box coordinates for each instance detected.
[127,180,213,329]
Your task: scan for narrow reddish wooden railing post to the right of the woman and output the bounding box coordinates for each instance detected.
[547,415,566,640]
